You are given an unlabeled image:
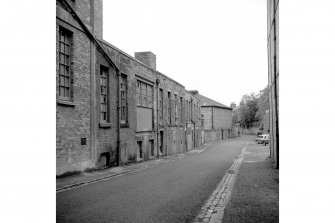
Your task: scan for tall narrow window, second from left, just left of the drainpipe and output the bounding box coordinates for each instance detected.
[100,66,109,122]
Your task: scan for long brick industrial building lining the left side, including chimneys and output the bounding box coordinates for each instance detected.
[56,0,202,175]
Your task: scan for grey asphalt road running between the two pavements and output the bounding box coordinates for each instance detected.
[56,138,247,223]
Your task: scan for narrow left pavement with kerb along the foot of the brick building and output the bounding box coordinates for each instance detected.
[56,142,217,193]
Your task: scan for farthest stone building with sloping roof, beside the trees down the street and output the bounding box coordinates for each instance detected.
[190,91,233,143]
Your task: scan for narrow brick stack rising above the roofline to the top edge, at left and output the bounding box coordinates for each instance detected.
[90,0,103,39]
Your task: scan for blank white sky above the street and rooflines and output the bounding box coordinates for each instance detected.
[103,0,268,106]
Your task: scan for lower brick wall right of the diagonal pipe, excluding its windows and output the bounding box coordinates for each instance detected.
[97,41,201,163]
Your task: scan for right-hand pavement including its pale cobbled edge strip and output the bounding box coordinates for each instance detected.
[194,135,279,223]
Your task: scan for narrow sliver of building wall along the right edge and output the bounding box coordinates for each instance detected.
[267,0,279,169]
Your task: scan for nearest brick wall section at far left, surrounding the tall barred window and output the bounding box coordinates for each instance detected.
[56,6,91,174]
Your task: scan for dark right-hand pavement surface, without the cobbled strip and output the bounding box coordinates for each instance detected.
[222,142,279,223]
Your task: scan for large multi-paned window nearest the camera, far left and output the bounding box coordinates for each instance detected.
[58,27,73,101]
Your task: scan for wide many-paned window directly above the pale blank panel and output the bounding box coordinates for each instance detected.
[136,80,153,108]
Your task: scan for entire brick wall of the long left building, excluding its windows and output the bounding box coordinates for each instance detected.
[56,0,202,175]
